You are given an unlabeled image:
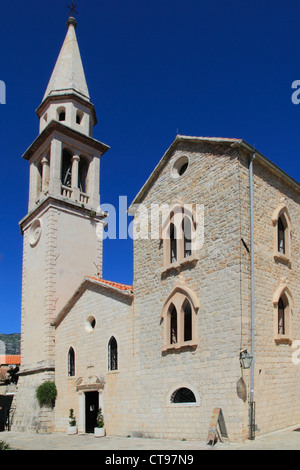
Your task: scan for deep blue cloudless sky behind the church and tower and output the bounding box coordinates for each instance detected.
[0,0,300,333]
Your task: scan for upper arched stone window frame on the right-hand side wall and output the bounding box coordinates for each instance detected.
[272,202,293,264]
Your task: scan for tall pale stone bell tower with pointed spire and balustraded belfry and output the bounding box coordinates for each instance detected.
[13,17,109,431]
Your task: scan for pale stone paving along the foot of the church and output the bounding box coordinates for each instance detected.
[0,425,300,453]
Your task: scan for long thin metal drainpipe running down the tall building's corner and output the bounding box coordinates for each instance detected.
[249,153,255,440]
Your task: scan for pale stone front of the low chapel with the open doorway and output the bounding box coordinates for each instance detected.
[55,278,136,435]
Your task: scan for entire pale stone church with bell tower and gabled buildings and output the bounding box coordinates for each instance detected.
[12,13,300,441]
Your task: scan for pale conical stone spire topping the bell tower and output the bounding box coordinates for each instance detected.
[43,17,90,102]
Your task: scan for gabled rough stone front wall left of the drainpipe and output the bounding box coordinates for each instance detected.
[134,143,248,439]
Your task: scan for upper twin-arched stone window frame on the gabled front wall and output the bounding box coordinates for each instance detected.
[160,203,199,274]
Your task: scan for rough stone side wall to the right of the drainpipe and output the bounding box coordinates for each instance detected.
[240,151,300,434]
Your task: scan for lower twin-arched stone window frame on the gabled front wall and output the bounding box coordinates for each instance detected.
[161,284,199,353]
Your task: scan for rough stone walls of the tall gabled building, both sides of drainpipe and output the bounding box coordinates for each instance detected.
[126,139,300,439]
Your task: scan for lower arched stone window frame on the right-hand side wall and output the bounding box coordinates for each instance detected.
[273,283,294,344]
